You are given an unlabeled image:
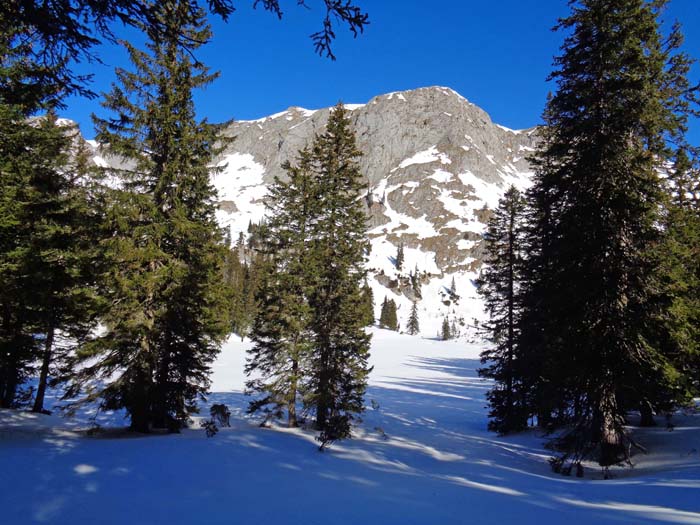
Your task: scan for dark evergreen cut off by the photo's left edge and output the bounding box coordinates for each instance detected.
[0,109,64,408]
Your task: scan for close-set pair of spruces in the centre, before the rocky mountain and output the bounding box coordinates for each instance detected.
[246,105,373,448]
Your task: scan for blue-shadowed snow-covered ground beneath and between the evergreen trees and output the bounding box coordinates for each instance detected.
[0,330,700,525]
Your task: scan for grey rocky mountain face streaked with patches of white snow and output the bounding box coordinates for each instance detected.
[214,87,537,336]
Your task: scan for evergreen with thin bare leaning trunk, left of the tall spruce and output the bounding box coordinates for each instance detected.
[24,132,102,412]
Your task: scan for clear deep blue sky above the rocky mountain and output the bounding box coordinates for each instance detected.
[64,0,700,145]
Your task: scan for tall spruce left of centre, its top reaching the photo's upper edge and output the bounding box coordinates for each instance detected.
[67,0,229,432]
